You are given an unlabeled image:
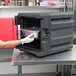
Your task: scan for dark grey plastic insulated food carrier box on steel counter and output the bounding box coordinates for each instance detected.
[15,12,74,57]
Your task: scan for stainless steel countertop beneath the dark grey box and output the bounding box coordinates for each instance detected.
[12,45,76,66]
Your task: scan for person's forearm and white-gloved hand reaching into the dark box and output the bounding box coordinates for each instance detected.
[0,34,34,48]
